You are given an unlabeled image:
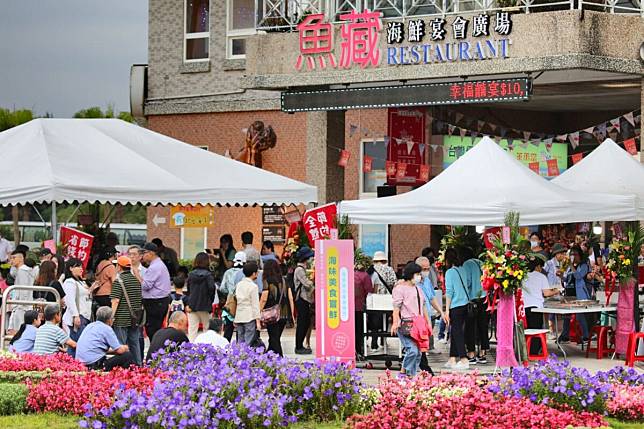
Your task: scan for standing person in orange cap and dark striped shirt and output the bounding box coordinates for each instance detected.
[110,256,143,365]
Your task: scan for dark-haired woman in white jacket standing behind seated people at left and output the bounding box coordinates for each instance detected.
[63,258,92,357]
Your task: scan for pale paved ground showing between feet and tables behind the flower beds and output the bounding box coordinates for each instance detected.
[262,329,644,385]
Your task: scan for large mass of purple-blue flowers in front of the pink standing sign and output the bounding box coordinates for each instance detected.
[81,344,360,429]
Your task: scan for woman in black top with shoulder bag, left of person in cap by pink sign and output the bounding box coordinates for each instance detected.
[259,259,295,356]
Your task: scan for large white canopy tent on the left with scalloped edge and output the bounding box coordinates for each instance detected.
[0,119,317,241]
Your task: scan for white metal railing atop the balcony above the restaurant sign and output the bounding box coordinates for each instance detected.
[255,0,644,31]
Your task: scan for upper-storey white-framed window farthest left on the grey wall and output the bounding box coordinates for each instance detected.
[183,0,210,62]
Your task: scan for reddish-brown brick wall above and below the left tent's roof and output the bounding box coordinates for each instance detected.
[148,111,306,258]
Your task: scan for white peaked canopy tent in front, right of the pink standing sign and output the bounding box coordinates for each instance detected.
[340,137,636,226]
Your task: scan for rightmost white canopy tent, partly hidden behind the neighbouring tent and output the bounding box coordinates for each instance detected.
[552,139,644,219]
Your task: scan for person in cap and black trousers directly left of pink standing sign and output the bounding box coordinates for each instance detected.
[293,246,315,355]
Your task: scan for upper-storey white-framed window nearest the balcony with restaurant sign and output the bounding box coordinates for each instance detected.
[226,0,255,58]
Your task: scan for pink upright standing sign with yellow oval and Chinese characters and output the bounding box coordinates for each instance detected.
[315,240,356,366]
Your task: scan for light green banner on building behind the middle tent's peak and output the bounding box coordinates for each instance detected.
[443,136,568,178]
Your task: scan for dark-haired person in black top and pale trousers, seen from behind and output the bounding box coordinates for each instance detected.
[186,252,216,342]
